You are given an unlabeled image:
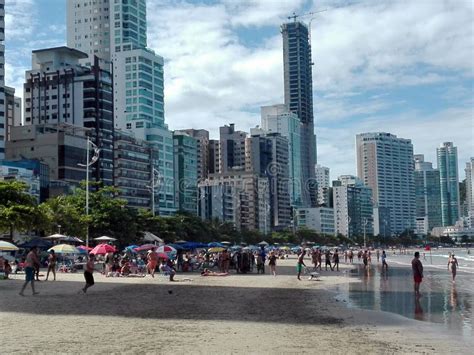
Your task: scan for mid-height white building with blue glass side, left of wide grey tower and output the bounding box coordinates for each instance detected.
[333,175,374,238]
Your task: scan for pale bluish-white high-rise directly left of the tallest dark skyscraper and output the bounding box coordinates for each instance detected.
[261,105,303,207]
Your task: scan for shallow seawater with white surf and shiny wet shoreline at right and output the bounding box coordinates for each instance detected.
[336,249,474,338]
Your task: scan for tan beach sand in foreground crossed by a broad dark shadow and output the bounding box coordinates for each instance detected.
[0,260,474,354]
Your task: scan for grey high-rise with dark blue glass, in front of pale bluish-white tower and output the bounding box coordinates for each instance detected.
[245,129,291,233]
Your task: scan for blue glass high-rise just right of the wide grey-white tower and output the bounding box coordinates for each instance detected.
[414,154,442,235]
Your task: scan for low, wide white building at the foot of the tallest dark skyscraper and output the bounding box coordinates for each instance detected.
[296,207,335,235]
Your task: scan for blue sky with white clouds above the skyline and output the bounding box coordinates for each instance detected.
[5,0,474,180]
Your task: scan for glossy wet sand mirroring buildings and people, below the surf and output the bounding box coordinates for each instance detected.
[339,265,474,337]
